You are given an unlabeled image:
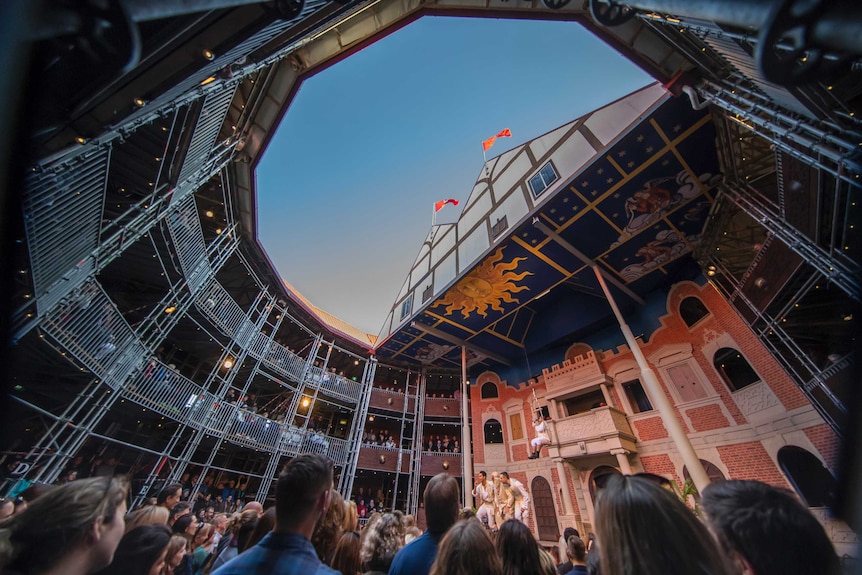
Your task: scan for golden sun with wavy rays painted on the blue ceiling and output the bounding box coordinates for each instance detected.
[437,248,532,319]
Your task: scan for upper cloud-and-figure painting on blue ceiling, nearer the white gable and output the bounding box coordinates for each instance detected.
[619,170,722,238]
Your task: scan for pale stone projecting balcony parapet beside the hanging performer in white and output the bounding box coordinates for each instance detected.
[548,406,637,459]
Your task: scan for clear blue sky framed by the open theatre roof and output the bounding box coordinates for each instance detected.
[257,17,653,334]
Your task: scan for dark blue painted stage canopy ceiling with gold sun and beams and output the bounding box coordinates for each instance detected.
[379,92,721,367]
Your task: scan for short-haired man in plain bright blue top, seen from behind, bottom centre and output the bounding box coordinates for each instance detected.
[389,473,461,575]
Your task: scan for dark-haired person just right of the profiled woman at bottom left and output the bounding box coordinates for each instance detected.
[93,524,171,575]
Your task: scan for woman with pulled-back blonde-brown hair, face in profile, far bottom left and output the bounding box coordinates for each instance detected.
[0,477,129,575]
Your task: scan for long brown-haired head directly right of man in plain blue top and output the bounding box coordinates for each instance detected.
[428,516,503,575]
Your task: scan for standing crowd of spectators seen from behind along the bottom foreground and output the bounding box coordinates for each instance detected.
[0,455,841,575]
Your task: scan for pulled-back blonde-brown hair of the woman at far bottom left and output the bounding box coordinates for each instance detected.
[0,477,129,573]
